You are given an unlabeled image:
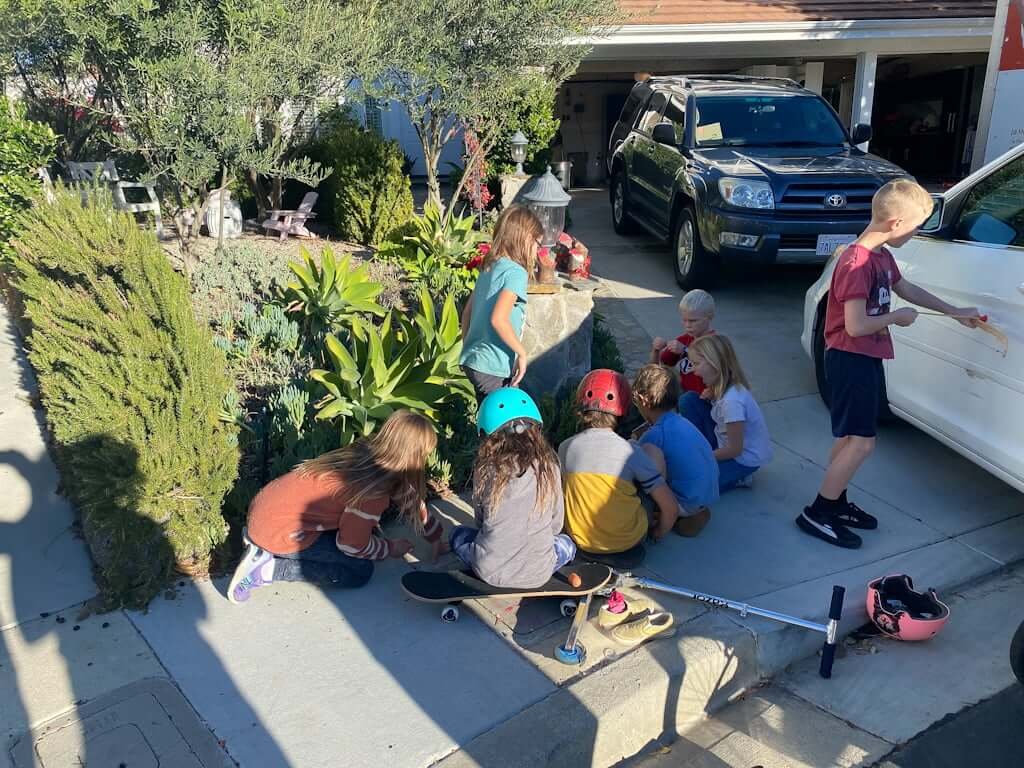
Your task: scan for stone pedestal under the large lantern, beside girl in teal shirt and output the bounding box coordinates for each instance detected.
[522,285,594,398]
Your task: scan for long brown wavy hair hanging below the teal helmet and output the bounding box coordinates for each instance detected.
[473,419,562,512]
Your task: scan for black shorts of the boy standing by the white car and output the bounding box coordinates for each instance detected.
[825,349,885,437]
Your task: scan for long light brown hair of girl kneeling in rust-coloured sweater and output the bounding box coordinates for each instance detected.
[296,411,437,520]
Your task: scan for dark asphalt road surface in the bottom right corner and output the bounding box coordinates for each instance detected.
[876,684,1024,768]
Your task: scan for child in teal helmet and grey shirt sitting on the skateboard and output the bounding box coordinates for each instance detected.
[451,387,575,589]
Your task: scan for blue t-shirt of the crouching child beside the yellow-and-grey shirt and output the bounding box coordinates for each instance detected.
[640,411,718,512]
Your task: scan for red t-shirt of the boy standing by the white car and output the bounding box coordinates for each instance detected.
[825,245,902,360]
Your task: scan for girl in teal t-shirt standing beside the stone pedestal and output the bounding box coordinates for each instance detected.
[459,206,544,400]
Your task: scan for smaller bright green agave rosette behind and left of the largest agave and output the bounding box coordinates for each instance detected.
[283,248,386,338]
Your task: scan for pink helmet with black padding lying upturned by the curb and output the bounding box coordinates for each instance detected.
[866,573,949,640]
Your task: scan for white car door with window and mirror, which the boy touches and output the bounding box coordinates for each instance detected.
[886,154,1024,486]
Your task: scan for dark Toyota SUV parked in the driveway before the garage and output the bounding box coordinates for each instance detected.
[608,75,908,289]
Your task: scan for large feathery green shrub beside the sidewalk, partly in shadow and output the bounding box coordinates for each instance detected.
[14,191,239,605]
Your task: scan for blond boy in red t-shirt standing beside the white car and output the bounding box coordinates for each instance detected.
[797,179,979,549]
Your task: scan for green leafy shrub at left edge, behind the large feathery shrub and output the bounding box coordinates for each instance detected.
[0,95,56,259]
